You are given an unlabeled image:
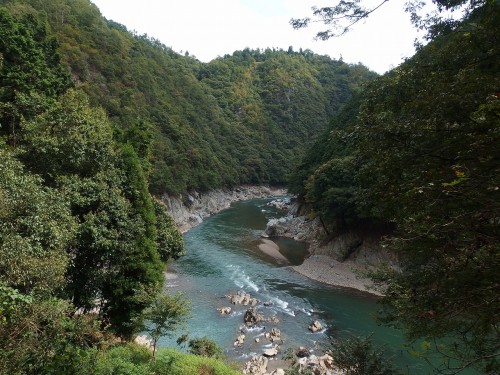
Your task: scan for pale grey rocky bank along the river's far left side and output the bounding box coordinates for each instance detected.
[162,186,286,232]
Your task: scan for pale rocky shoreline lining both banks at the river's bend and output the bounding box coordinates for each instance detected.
[162,185,395,295]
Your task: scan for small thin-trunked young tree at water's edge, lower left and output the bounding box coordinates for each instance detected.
[142,293,190,358]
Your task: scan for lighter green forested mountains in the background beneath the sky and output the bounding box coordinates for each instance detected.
[2,0,375,194]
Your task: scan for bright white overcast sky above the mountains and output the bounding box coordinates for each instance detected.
[91,0,417,74]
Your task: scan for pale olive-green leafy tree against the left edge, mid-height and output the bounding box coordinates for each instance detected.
[0,149,75,295]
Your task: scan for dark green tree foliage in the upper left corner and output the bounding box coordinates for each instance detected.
[0,8,70,144]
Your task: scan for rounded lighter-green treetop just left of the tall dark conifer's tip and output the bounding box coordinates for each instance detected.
[22,90,113,184]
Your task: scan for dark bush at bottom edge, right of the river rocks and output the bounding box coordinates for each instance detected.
[332,337,400,375]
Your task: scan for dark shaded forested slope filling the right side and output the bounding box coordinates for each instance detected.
[291,1,500,374]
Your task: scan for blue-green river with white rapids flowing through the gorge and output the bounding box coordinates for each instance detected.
[159,198,428,374]
